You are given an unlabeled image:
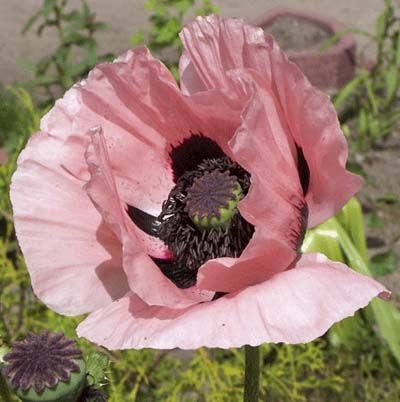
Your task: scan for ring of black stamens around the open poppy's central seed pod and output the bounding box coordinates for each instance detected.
[155,156,254,288]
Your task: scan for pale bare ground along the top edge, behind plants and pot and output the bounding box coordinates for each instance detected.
[0,0,383,84]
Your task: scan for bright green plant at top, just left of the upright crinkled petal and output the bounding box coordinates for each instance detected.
[130,0,218,78]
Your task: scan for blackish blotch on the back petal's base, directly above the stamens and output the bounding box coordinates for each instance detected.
[170,134,225,182]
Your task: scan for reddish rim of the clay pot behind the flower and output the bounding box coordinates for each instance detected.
[251,7,356,57]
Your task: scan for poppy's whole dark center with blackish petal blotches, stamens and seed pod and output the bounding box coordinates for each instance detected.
[128,134,309,288]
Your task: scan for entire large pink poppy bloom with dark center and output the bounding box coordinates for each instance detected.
[11,16,387,349]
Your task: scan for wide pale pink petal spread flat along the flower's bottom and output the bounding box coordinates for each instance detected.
[78,254,387,349]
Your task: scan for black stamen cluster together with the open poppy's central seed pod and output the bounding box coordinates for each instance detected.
[155,152,254,288]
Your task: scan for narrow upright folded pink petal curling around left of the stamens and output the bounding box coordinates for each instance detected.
[85,125,214,308]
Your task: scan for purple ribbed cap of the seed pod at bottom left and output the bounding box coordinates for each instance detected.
[3,331,82,392]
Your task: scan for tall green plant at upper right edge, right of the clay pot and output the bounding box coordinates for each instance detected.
[330,0,400,151]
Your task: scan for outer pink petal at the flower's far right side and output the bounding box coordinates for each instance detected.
[267,36,362,227]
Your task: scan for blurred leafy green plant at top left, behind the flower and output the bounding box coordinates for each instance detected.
[22,0,113,101]
